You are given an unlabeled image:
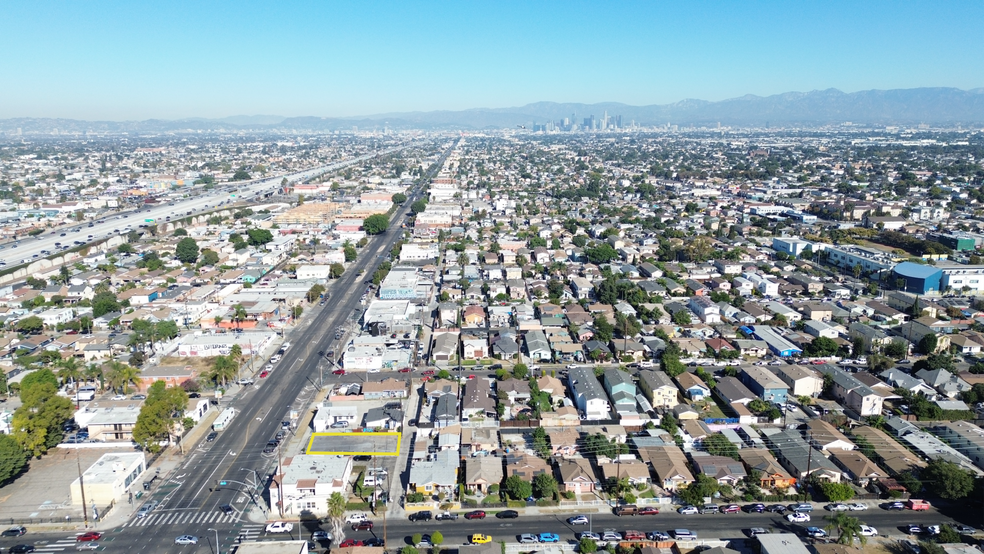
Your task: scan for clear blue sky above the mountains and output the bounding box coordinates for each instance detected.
[0,0,984,121]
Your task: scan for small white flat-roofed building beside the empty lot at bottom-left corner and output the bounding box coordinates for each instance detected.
[71,452,147,508]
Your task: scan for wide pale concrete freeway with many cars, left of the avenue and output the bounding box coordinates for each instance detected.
[0,146,407,266]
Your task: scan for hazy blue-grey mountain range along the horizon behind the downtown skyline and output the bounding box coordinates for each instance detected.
[0,87,984,134]
